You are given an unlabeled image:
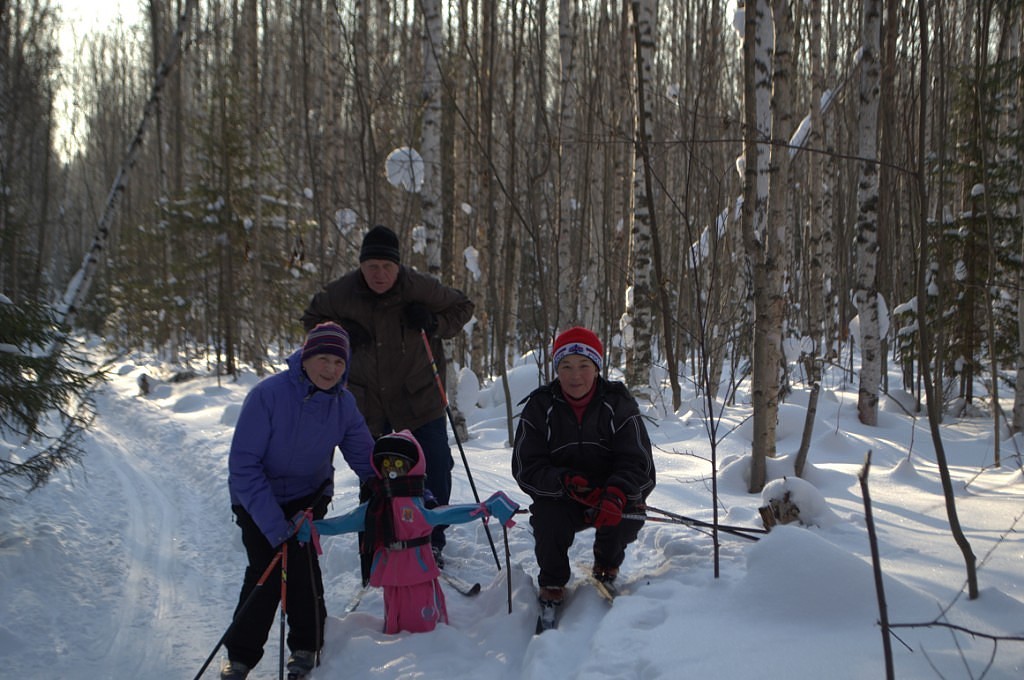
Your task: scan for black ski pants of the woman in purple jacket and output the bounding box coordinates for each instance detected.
[224,496,331,668]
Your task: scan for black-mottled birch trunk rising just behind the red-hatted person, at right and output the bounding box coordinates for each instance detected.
[626,0,654,401]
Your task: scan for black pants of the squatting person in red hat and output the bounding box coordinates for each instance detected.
[529,499,643,588]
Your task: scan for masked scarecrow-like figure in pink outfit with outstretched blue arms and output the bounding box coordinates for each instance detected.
[298,430,519,634]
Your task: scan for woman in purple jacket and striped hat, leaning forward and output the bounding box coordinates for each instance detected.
[220,322,374,680]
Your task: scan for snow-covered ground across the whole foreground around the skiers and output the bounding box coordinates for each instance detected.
[0,348,1024,680]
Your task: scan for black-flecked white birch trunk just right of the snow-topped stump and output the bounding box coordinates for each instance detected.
[853,0,882,425]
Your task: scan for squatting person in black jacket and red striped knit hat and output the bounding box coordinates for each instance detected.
[512,327,655,603]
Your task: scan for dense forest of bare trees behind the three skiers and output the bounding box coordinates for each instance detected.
[0,0,1024,489]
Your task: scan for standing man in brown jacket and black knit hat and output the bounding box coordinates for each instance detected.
[302,225,473,566]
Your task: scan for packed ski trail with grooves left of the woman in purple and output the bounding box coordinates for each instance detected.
[8,384,244,678]
